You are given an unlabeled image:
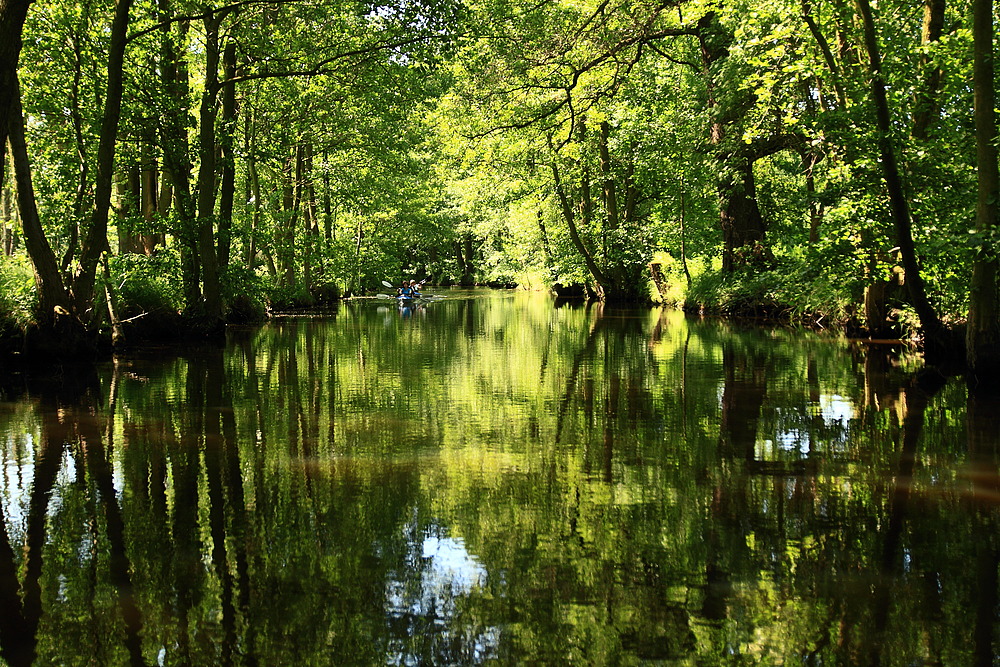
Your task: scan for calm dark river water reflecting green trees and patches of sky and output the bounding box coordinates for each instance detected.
[0,291,1000,665]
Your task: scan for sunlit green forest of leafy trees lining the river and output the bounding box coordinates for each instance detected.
[0,0,1000,376]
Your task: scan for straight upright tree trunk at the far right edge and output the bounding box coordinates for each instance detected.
[966,0,1000,390]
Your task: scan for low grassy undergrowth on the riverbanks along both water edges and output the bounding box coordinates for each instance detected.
[0,262,961,361]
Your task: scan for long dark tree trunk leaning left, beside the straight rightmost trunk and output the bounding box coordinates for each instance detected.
[856,0,946,354]
